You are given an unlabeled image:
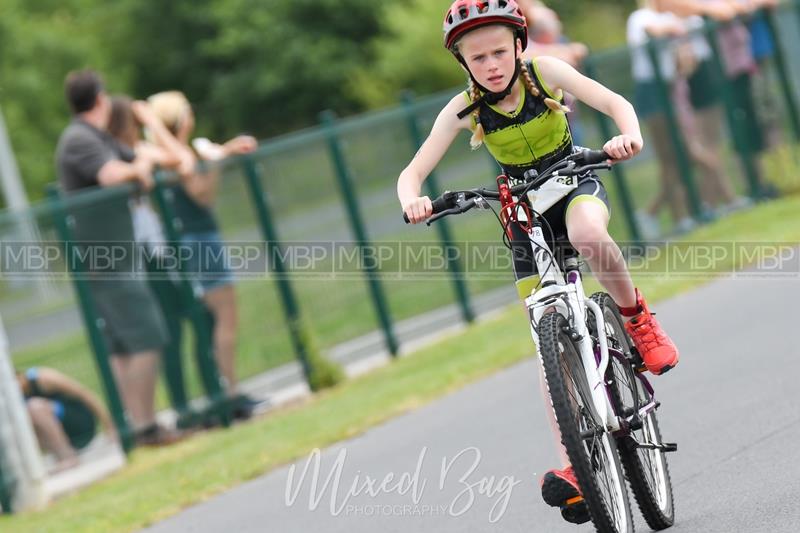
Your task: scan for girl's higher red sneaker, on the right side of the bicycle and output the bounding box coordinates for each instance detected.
[620,289,680,375]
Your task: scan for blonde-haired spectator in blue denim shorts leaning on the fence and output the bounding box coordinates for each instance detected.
[147,91,257,418]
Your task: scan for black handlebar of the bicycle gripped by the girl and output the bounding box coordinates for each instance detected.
[403,150,611,226]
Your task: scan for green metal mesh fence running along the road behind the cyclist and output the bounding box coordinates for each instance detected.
[0,4,800,474]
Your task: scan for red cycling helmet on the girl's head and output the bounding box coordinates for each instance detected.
[443,0,528,56]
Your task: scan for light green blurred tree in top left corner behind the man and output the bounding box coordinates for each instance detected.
[0,0,124,200]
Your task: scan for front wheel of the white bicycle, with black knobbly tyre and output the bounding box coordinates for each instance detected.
[538,313,633,533]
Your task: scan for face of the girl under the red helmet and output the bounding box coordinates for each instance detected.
[458,26,522,92]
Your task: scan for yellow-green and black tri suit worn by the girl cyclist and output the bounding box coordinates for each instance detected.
[463,60,609,298]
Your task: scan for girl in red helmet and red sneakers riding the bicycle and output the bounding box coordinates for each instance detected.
[397,0,678,522]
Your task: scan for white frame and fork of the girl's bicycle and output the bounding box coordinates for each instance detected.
[525,185,620,432]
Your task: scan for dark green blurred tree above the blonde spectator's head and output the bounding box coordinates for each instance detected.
[111,0,392,136]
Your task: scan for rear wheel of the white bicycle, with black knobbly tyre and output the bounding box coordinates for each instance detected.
[590,293,675,530]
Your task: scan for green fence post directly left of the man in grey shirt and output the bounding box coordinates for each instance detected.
[47,184,134,453]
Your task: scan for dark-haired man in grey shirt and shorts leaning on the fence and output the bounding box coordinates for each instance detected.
[56,70,174,444]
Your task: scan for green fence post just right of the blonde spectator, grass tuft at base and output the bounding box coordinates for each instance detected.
[242,157,341,391]
